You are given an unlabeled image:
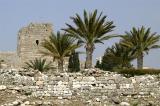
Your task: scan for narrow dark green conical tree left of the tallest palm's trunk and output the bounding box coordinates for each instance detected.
[68,51,80,72]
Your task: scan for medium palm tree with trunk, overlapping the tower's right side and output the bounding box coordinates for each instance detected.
[41,32,80,72]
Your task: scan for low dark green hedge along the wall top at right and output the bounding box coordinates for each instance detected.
[116,69,160,77]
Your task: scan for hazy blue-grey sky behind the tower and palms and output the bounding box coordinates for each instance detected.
[0,0,160,68]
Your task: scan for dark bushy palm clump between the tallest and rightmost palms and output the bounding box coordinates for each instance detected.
[102,43,135,70]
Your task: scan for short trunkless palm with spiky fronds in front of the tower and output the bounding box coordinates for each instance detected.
[24,58,54,72]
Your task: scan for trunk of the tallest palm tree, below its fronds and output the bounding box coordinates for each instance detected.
[85,45,94,69]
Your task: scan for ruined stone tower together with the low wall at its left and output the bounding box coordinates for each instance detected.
[0,23,52,67]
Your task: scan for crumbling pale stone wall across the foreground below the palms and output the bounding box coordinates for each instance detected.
[0,70,160,106]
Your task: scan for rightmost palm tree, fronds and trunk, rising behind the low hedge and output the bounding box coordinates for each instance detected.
[121,26,160,69]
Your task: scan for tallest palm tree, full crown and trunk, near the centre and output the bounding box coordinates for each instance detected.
[62,10,115,68]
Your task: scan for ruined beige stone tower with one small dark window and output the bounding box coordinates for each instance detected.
[17,23,52,64]
